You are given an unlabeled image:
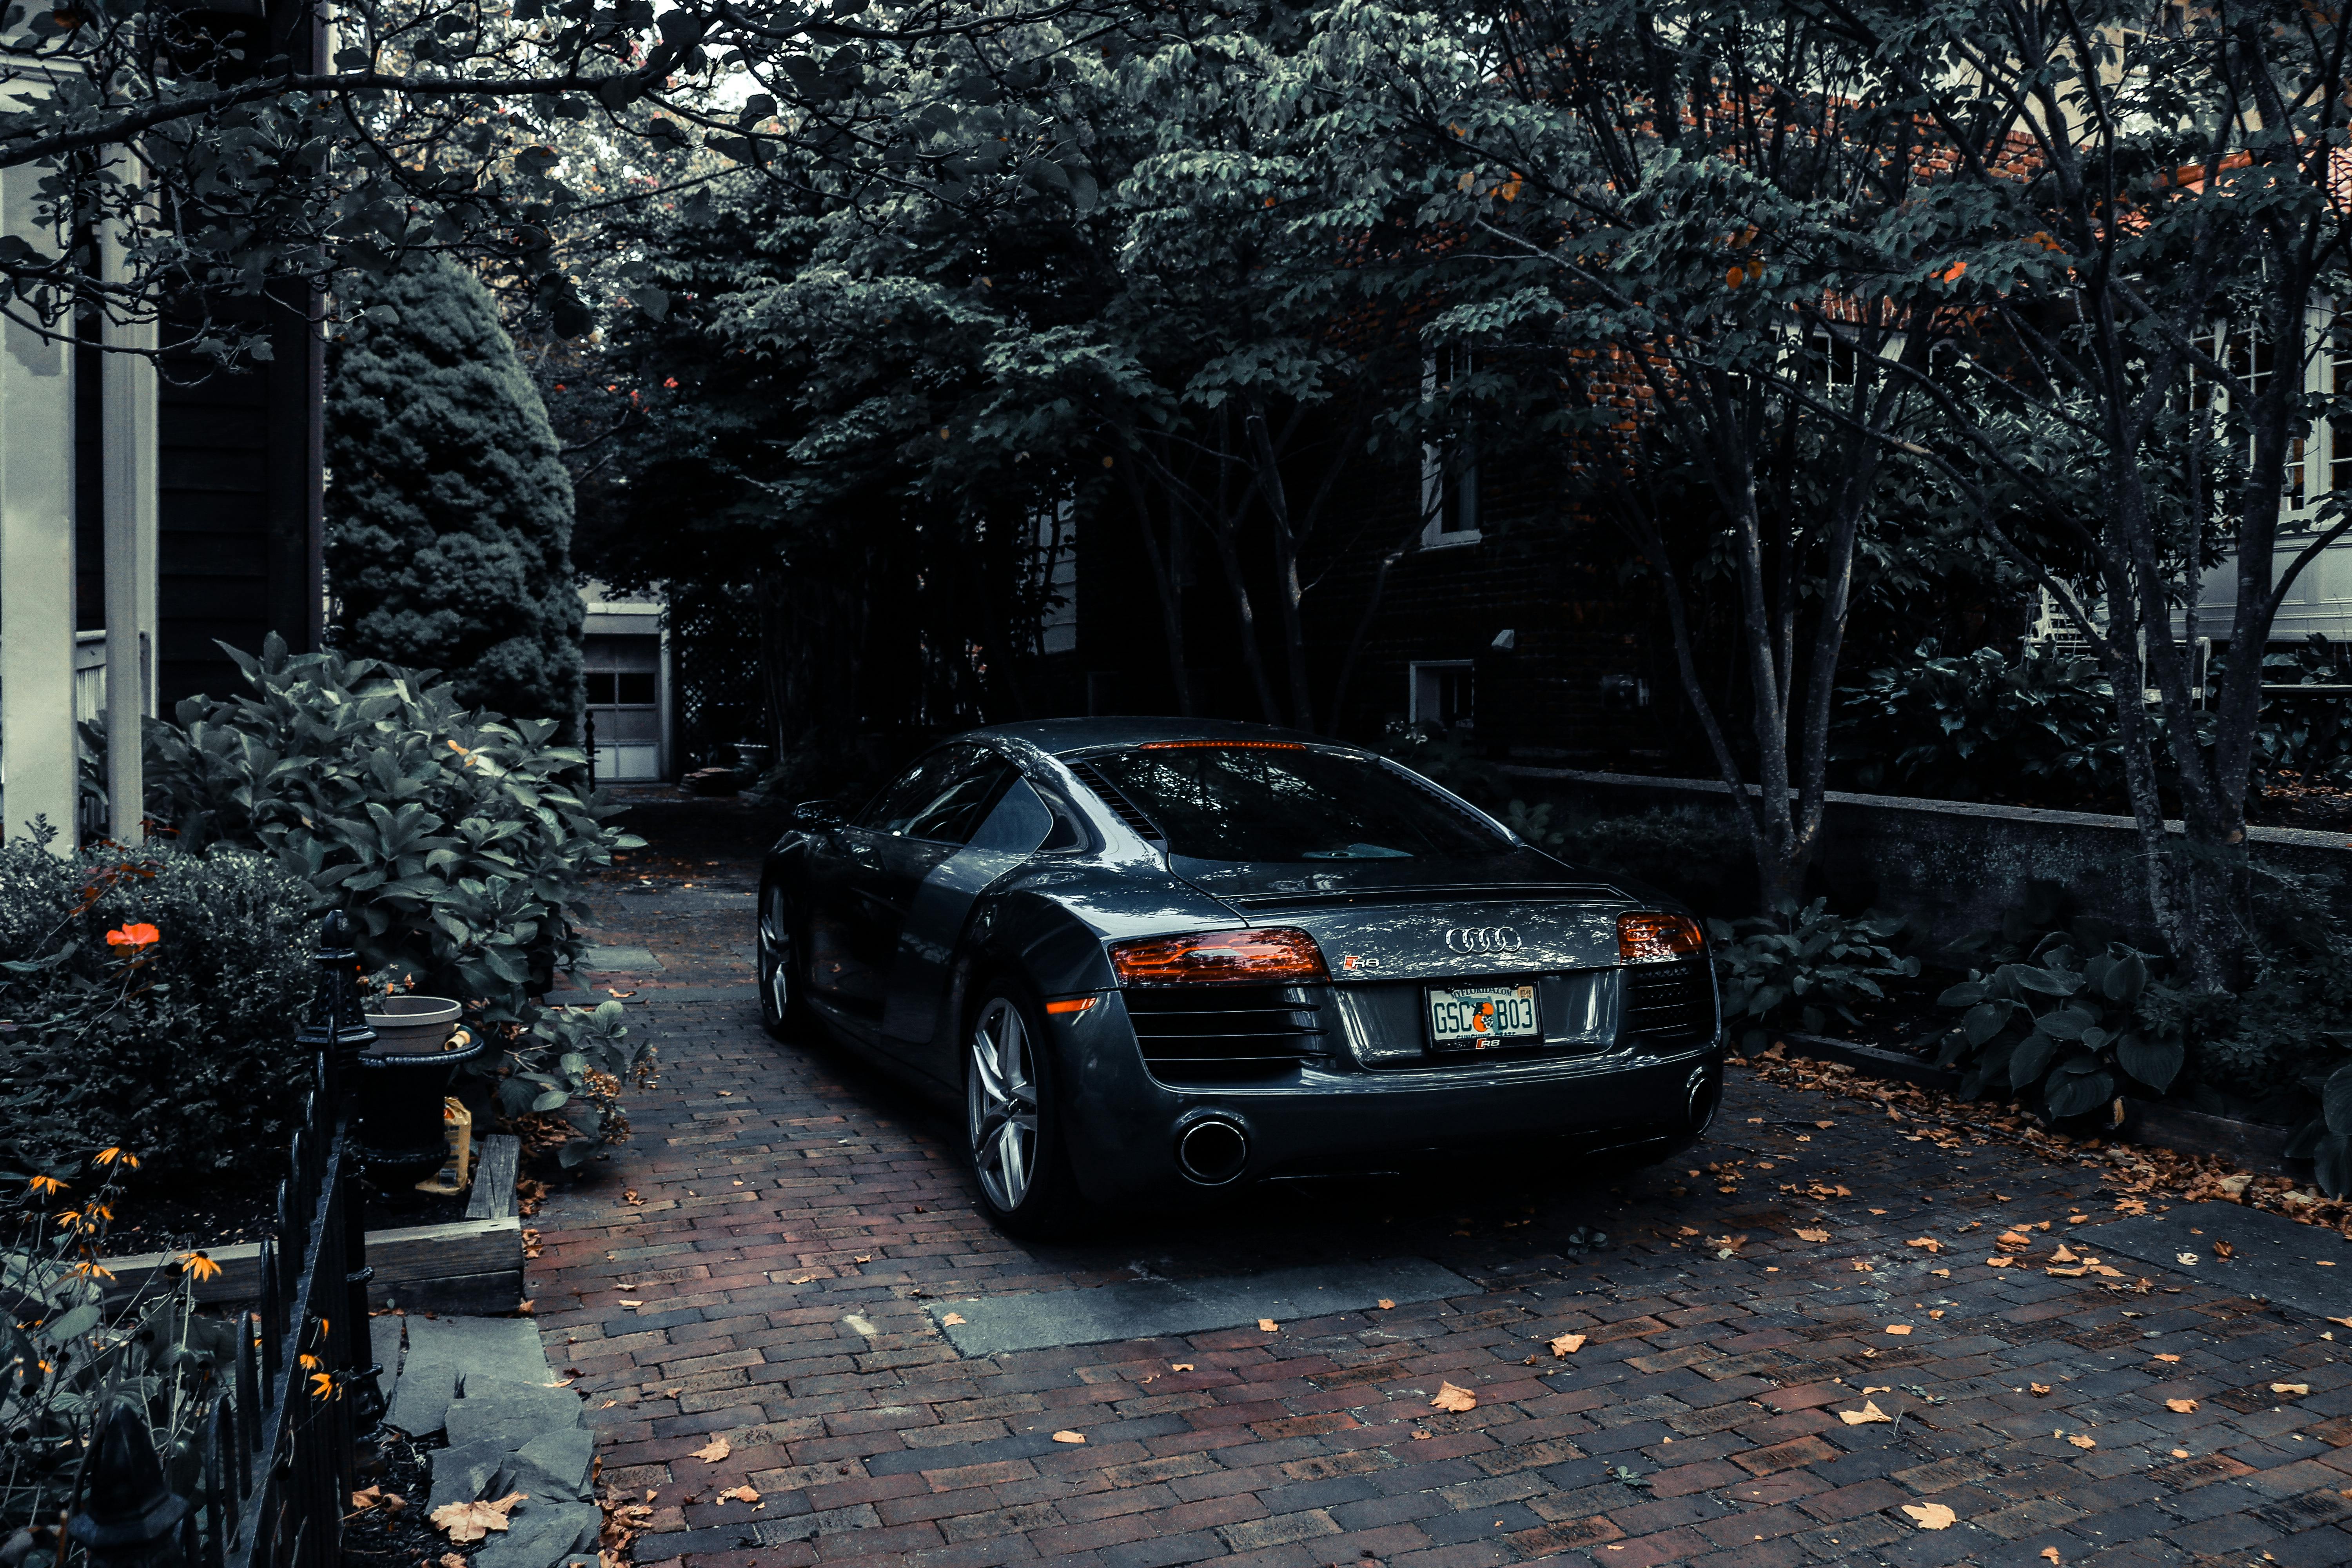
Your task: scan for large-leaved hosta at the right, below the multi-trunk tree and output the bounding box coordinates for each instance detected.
[1940,933,2187,1122]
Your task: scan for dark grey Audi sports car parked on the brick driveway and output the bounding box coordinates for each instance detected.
[760,719,1724,1232]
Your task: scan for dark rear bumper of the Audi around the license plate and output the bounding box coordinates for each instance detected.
[1054,1009,1724,1203]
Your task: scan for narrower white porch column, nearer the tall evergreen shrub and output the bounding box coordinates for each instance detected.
[99,223,155,846]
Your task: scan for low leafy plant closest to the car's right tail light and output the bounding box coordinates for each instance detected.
[1708,898,1919,1044]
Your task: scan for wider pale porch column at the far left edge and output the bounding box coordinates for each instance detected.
[0,169,75,853]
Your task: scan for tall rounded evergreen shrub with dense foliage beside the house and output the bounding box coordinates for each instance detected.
[327,256,581,736]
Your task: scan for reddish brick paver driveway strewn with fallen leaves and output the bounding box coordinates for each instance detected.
[532,851,2352,1568]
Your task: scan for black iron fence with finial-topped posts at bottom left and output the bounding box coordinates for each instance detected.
[66,912,383,1568]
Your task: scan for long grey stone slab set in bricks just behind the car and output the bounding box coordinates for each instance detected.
[931,1258,1477,1356]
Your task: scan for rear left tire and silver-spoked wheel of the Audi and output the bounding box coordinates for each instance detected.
[962,985,1089,1239]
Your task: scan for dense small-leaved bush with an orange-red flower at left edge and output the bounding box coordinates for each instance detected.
[0,839,318,1178]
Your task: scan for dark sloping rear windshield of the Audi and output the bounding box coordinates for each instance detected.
[1089,745,1512,860]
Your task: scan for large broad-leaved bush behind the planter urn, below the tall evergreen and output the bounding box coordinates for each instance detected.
[111,637,644,1164]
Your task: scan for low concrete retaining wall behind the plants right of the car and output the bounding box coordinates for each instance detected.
[1505,766,2352,947]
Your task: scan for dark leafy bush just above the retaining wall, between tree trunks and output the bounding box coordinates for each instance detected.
[1830,642,2124,802]
